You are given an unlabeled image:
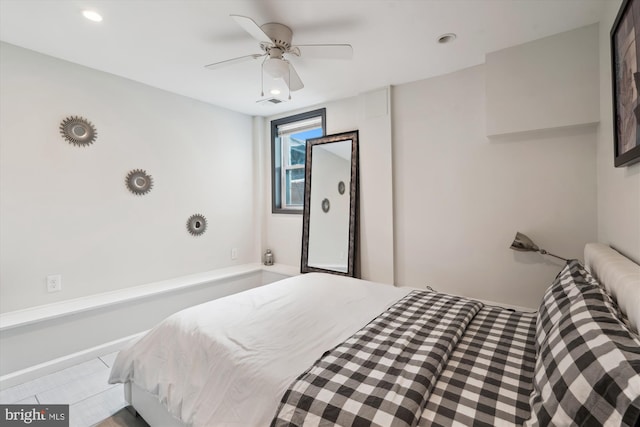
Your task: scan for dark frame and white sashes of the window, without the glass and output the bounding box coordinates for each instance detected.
[271,108,327,215]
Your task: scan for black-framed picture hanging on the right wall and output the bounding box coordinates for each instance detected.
[611,0,640,167]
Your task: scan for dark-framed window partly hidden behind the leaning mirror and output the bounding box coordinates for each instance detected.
[271,108,326,214]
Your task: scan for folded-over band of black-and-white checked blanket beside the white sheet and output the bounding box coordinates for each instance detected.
[271,291,482,426]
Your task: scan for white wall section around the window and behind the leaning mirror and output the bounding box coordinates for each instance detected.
[262,88,394,283]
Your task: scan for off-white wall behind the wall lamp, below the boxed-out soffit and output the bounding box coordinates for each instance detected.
[392,65,596,307]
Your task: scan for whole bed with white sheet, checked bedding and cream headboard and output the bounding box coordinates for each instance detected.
[109,244,640,427]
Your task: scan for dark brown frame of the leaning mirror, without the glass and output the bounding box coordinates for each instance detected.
[300,130,359,277]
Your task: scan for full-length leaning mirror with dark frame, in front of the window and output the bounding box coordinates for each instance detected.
[301,130,358,277]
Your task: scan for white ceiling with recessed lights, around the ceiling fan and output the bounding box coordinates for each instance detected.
[0,0,611,116]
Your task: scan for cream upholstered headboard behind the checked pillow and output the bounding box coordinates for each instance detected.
[584,243,640,333]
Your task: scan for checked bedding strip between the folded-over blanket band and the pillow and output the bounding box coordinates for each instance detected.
[419,306,536,427]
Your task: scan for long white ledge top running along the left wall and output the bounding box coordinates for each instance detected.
[0,263,270,331]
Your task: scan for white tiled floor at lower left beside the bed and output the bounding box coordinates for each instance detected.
[0,353,127,427]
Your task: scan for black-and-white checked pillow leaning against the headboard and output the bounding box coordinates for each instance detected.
[525,260,640,426]
